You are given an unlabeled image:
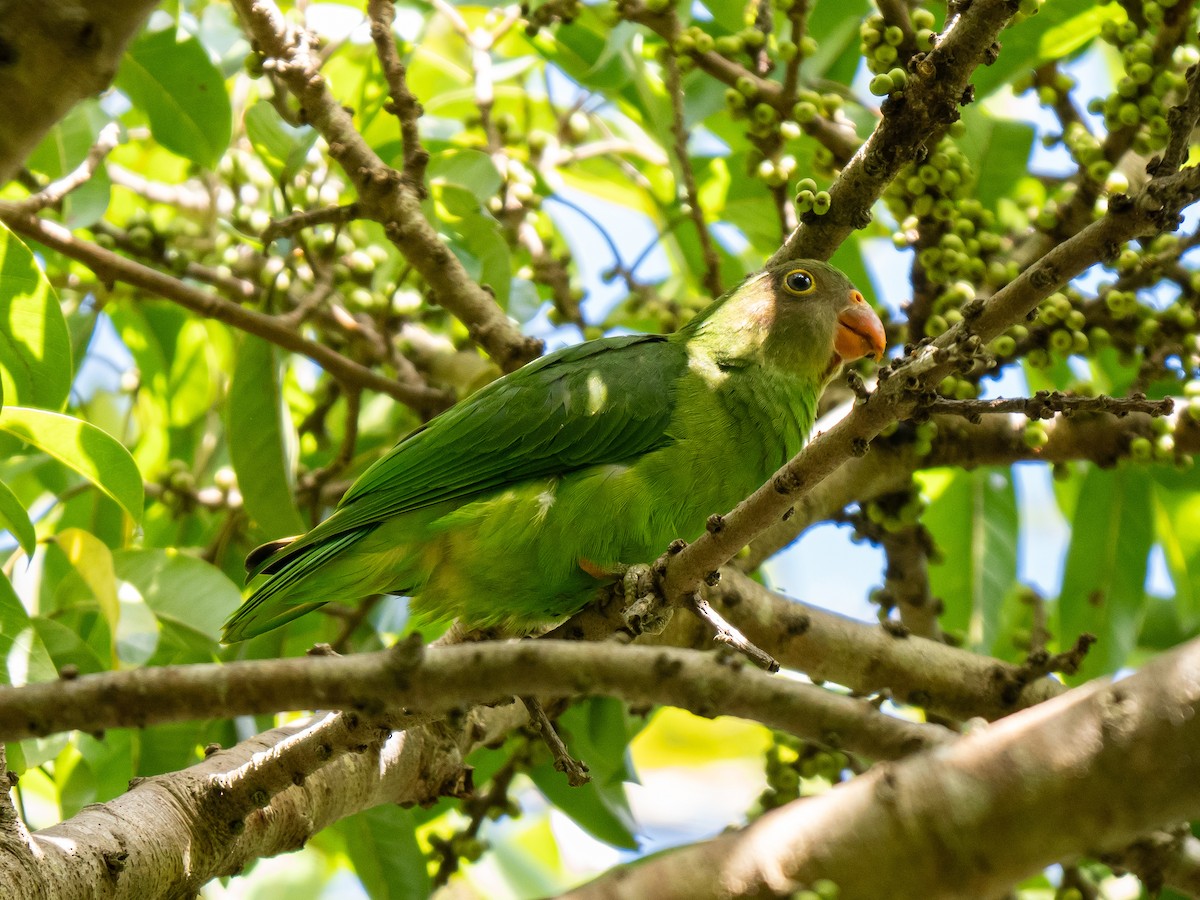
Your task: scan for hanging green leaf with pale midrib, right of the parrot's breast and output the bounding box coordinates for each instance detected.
[918,469,1018,654]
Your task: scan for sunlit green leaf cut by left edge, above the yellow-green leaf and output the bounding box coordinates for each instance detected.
[0,223,71,409]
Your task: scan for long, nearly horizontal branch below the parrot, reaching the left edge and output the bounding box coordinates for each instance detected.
[0,641,946,758]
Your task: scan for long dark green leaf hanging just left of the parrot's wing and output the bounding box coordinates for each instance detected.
[228,335,306,538]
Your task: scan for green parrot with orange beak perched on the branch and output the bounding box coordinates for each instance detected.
[224,259,884,642]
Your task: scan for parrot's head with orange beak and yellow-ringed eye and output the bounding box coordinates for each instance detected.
[688,259,887,384]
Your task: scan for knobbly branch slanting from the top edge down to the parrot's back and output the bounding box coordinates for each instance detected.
[234,0,541,371]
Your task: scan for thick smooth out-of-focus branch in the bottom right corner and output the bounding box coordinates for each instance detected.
[568,641,1200,900]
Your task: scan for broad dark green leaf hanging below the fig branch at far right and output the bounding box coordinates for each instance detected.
[1057,466,1154,680]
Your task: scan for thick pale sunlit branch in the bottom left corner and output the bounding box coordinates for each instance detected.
[0,703,526,900]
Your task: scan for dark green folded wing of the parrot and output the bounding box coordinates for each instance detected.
[254,335,686,574]
